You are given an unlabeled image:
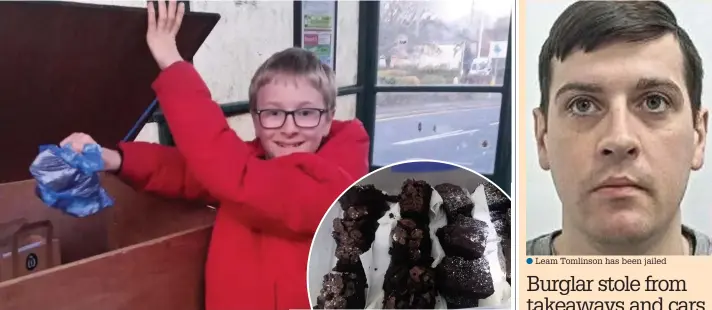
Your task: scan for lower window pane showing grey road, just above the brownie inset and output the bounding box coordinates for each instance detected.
[373,93,502,174]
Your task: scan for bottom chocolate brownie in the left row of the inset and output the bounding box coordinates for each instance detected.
[314,272,368,309]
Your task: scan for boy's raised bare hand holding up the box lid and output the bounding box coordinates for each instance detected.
[146,0,185,70]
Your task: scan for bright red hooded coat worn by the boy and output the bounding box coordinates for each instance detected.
[114,62,369,310]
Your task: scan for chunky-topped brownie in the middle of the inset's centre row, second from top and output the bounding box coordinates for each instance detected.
[388,218,433,265]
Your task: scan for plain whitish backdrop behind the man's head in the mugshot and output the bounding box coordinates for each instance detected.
[520,0,712,239]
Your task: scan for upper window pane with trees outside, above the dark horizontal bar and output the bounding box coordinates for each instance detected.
[378,0,511,85]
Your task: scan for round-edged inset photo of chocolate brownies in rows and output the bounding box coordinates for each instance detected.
[307,160,511,309]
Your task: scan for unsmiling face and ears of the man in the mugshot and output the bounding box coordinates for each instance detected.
[534,35,707,243]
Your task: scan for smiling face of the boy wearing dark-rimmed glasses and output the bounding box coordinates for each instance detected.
[252,75,333,157]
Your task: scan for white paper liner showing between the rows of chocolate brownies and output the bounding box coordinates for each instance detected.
[310,185,511,309]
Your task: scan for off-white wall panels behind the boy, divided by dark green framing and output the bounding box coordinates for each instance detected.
[74,0,359,142]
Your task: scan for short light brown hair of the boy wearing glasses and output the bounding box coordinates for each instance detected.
[249,47,337,112]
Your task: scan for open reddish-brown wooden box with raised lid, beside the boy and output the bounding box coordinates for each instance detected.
[0,2,220,310]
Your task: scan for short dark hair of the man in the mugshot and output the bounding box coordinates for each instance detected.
[539,1,703,119]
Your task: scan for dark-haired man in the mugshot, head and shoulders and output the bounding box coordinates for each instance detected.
[526,1,712,255]
